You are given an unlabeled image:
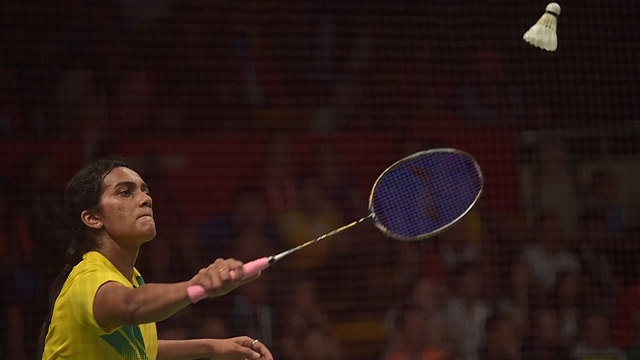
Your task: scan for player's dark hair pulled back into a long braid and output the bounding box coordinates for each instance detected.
[39,157,129,351]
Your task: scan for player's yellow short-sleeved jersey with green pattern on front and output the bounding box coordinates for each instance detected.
[42,251,158,360]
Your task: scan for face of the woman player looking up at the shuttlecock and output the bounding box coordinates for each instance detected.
[97,167,156,248]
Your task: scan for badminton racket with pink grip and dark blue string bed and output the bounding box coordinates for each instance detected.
[187,148,484,302]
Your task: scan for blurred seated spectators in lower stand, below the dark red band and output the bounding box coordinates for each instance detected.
[0,141,640,360]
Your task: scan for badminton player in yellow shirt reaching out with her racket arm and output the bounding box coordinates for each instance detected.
[40,159,273,360]
